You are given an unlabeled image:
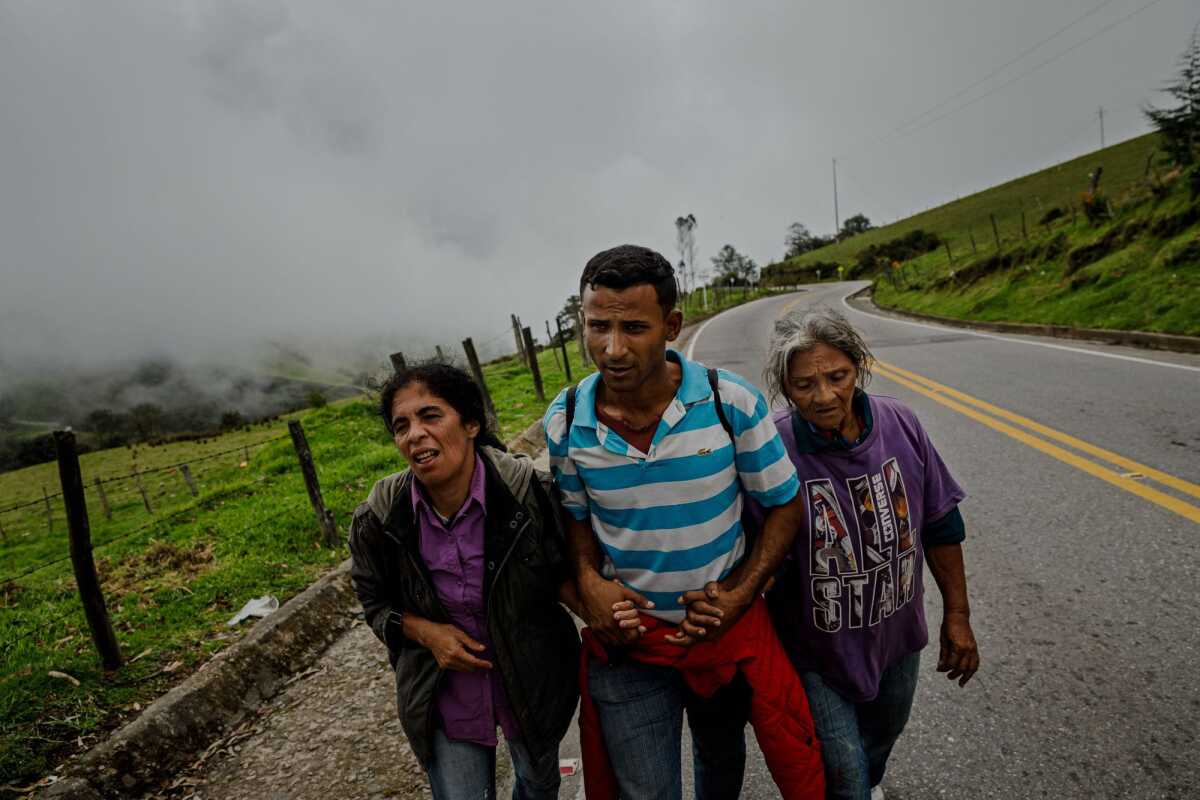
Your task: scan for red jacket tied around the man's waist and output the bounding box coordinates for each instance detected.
[580,597,824,800]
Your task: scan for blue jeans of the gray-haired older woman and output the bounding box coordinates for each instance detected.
[800,652,920,800]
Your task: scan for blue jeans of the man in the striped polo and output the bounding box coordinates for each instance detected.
[588,656,749,800]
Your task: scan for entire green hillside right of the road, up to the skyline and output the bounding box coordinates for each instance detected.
[763,128,1200,336]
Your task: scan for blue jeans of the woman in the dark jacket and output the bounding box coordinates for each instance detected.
[425,728,562,800]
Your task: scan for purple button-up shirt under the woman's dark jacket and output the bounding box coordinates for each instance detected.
[413,453,521,747]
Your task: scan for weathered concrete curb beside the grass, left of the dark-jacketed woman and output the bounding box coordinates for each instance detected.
[37,559,358,800]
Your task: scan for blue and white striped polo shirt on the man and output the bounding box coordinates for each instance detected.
[542,350,799,622]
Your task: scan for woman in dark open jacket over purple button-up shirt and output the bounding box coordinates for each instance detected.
[349,363,580,800]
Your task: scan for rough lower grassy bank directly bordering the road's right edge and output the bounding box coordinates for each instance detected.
[875,164,1200,336]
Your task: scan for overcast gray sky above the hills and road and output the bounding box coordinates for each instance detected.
[0,0,1200,369]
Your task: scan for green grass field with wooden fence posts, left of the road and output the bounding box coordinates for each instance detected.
[0,344,588,784]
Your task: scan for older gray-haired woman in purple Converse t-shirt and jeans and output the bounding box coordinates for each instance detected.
[763,308,979,800]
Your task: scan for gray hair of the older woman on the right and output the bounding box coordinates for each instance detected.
[762,306,875,402]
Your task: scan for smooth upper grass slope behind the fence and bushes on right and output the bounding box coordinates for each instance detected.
[784,134,1157,275]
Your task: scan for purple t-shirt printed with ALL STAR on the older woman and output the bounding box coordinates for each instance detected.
[774,395,966,703]
